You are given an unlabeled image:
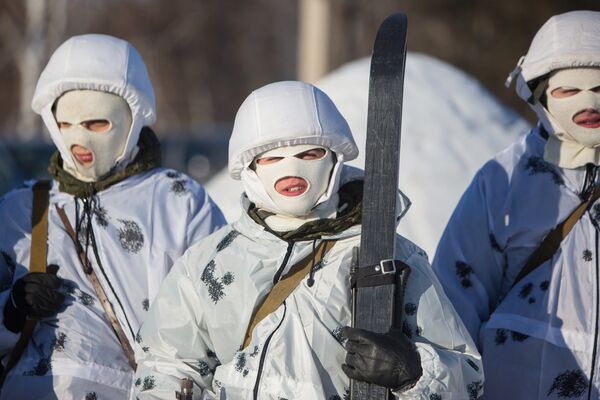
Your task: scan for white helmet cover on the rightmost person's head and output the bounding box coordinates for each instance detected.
[506,11,600,102]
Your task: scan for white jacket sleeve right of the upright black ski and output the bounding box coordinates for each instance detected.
[394,241,483,400]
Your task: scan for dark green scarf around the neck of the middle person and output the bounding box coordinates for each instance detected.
[248,181,363,241]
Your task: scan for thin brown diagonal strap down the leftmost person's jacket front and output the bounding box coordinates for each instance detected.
[56,205,137,371]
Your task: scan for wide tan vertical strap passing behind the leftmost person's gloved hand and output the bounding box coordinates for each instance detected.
[0,180,50,386]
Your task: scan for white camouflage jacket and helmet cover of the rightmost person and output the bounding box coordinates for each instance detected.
[433,12,600,400]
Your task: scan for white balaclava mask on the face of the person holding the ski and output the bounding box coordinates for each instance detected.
[255,145,334,217]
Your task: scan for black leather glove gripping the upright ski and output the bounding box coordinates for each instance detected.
[342,326,423,390]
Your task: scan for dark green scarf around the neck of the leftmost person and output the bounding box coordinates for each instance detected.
[48,127,161,197]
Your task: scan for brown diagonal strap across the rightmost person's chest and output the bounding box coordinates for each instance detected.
[512,185,600,287]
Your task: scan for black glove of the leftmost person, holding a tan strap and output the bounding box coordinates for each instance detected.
[4,264,65,333]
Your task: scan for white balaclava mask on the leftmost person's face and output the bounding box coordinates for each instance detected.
[54,90,132,182]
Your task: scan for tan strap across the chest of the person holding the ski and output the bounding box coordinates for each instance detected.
[242,240,335,349]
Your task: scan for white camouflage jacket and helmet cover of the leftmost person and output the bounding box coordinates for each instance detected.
[0,35,225,400]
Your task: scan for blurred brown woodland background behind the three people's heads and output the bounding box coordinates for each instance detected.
[0,0,600,139]
